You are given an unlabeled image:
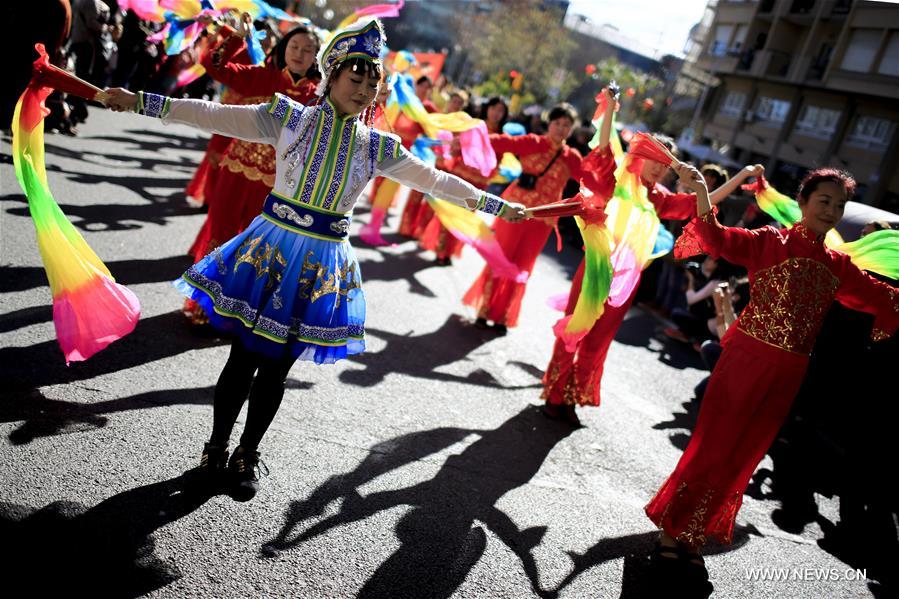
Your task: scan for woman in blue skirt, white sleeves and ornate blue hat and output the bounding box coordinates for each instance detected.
[107,19,524,501]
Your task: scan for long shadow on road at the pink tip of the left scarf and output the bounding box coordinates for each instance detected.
[0,312,228,402]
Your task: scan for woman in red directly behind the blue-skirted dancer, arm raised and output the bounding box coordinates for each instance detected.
[182,13,320,324]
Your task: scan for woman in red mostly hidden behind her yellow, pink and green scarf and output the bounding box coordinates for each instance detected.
[542,101,763,426]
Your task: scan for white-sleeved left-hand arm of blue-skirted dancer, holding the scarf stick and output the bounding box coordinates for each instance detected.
[106,87,280,145]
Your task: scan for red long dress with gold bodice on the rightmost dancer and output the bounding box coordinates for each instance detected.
[646,212,899,549]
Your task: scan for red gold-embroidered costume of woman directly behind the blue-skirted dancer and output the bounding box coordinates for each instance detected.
[192,35,318,261]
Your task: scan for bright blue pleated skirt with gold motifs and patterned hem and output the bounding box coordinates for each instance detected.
[174,215,365,364]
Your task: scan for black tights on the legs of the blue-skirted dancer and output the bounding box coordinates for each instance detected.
[209,339,296,450]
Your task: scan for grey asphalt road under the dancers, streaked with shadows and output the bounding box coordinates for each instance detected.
[0,105,878,599]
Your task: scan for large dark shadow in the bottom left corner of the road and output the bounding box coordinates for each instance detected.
[0,477,209,597]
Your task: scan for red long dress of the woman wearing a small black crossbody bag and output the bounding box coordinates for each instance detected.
[462,133,582,327]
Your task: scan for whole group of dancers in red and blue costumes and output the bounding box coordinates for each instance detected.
[10,3,899,587]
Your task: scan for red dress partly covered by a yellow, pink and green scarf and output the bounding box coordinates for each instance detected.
[541,151,696,406]
